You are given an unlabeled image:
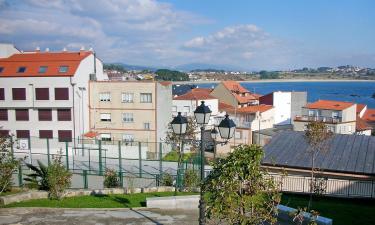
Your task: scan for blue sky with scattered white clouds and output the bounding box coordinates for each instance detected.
[0,0,375,71]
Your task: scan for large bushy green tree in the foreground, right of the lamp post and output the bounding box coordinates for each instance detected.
[203,145,281,225]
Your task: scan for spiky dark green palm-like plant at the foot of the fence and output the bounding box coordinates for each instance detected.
[23,160,49,191]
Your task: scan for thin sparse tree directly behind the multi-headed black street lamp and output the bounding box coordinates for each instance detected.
[166,117,199,195]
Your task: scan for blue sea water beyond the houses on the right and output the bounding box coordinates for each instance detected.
[198,81,375,108]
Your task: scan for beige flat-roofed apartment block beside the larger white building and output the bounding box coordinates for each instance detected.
[89,81,172,142]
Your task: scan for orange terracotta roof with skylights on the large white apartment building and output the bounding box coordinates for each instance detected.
[0,51,92,77]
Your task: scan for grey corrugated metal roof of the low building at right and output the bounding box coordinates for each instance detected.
[262,131,375,175]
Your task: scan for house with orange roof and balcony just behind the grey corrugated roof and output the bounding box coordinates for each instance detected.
[294,100,357,134]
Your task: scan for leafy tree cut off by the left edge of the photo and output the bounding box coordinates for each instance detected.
[0,137,21,194]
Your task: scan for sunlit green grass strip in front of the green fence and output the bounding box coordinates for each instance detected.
[5,192,197,208]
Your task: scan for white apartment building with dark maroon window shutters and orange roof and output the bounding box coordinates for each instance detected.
[0,44,107,141]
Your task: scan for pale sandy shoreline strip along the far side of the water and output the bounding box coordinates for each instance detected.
[172,79,375,84]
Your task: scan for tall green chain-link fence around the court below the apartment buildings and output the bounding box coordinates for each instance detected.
[11,137,206,188]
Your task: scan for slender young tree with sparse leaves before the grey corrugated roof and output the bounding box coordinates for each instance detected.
[305,122,332,211]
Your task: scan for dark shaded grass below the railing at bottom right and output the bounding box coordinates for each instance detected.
[281,194,375,225]
